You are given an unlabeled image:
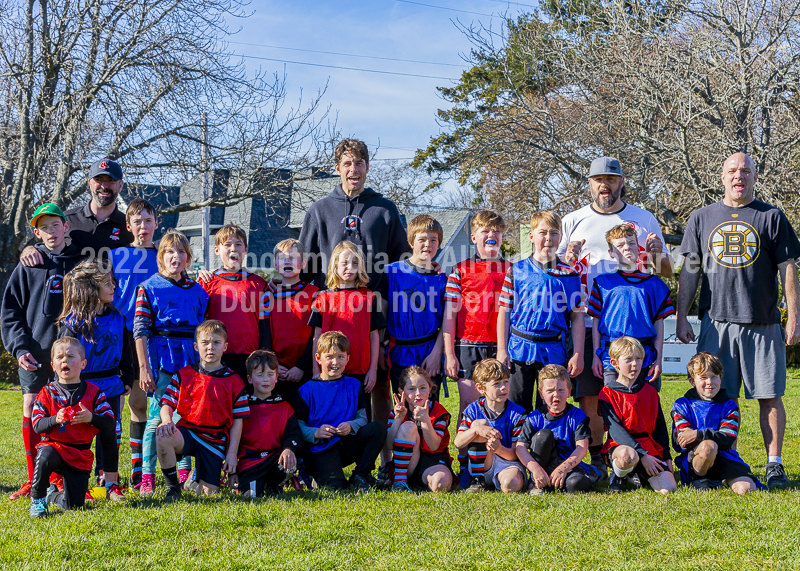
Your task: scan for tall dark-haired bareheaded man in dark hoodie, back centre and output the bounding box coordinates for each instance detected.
[300,139,411,293]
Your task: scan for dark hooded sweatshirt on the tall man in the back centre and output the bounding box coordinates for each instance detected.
[300,184,411,291]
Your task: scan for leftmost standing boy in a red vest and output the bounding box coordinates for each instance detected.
[197,224,271,379]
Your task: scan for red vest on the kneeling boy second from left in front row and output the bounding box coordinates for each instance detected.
[178,365,244,433]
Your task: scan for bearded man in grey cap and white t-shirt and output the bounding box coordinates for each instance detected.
[558,157,672,478]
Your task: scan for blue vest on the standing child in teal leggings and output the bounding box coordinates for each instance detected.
[141,274,208,375]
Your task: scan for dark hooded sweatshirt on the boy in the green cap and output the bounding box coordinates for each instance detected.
[0,244,83,363]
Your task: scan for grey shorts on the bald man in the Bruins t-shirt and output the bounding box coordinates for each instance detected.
[697,314,786,399]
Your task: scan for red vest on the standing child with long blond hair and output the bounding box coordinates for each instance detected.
[313,287,375,375]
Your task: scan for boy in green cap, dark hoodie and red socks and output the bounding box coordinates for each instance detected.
[0,204,82,499]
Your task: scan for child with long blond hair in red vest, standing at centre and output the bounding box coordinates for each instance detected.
[308,240,386,404]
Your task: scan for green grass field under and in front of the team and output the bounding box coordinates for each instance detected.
[0,371,800,571]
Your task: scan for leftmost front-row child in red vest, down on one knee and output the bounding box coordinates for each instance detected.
[30,337,117,517]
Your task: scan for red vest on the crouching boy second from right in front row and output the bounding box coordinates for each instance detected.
[598,383,664,458]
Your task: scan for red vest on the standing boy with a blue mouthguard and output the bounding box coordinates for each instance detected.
[456,259,511,343]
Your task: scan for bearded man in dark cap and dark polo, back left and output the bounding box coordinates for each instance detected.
[20,158,133,267]
